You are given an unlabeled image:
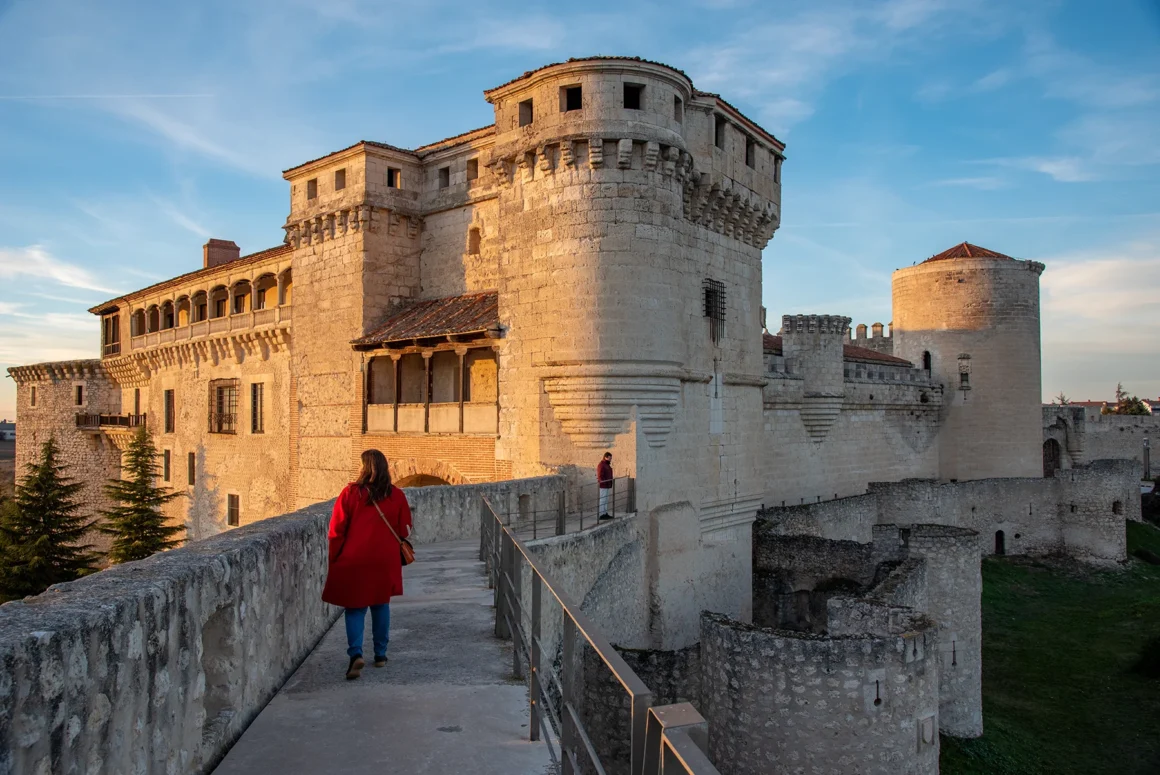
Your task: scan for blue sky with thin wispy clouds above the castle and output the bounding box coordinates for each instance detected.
[0,0,1160,417]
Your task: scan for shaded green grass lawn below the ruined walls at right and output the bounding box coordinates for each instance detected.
[941,523,1160,775]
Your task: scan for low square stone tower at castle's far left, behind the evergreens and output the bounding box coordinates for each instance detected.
[8,361,129,551]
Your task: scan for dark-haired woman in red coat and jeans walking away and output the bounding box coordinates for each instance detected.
[322,449,411,679]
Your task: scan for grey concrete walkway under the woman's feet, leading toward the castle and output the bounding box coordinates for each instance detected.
[215,539,554,775]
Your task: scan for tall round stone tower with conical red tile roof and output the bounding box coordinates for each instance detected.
[893,242,1044,480]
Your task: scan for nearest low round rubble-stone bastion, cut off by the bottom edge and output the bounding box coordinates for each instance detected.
[699,613,938,775]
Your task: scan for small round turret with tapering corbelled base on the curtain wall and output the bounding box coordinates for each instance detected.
[782,314,850,442]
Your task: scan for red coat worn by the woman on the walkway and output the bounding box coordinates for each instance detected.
[322,484,411,608]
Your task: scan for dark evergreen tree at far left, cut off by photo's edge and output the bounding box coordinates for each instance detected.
[0,439,100,599]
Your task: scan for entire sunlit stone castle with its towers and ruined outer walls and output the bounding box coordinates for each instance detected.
[9,57,1139,773]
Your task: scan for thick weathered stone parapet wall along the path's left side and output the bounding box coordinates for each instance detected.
[0,504,339,775]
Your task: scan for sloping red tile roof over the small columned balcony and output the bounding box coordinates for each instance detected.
[351,291,500,347]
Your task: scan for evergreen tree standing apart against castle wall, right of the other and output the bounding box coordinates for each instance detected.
[100,426,184,563]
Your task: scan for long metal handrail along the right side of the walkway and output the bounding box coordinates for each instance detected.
[479,498,718,775]
